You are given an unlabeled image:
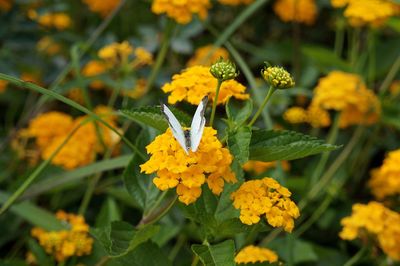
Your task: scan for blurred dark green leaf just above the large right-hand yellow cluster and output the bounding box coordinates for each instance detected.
[301,45,350,72]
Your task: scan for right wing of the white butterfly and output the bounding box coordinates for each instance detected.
[190,96,208,152]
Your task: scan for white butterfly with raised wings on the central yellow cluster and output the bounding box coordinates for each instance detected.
[161,96,208,154]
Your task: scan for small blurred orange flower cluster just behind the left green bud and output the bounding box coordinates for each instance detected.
[186,45,229,67]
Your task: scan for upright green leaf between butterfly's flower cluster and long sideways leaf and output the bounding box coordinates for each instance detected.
[228,126,251,164]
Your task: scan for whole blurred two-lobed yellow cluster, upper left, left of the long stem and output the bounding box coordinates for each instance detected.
[97,41,153,68]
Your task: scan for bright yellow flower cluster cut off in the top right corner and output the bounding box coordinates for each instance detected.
[331,0,399,27]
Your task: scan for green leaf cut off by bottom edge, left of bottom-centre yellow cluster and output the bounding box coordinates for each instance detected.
[192,240,235,266]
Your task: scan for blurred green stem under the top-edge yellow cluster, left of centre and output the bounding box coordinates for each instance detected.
[145,19,176,92]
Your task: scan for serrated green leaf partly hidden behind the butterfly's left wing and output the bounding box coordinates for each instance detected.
[120,106,191,132]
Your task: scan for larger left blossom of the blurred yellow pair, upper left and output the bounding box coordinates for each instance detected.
[97,41,134,67]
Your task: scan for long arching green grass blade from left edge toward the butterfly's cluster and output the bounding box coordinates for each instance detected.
[0,73,146,160]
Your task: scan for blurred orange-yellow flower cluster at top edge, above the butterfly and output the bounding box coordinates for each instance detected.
[151,0,211,24]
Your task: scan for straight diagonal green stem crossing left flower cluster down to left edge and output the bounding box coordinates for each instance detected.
[0,120,88,215]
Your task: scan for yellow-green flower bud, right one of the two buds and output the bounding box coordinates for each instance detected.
[261,66,295,89]
